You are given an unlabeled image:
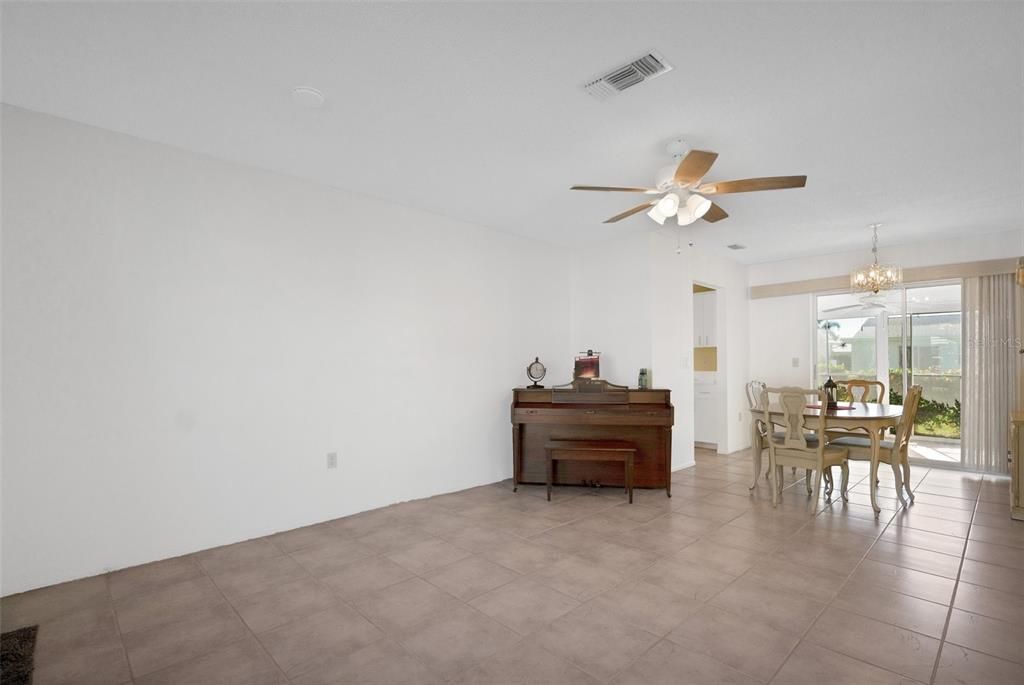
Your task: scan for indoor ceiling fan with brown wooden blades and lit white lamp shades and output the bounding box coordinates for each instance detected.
[571,139,807,226]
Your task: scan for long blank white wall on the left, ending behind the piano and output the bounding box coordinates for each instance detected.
[2,108,577,595]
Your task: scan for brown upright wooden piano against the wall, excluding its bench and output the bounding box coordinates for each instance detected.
[512,379,675,497]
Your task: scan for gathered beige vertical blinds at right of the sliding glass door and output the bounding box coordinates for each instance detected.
[961,273,1021,473]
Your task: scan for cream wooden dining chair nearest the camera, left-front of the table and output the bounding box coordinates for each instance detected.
[761,387,850,506]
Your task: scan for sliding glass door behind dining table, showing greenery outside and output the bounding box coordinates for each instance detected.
[814,282,963,463]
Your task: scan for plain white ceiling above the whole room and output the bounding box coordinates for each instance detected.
[2,2,1024,262]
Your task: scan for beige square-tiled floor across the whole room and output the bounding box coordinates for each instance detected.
[2,452,1024,685]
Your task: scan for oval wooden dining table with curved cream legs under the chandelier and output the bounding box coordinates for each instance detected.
[751,402,910,516]
